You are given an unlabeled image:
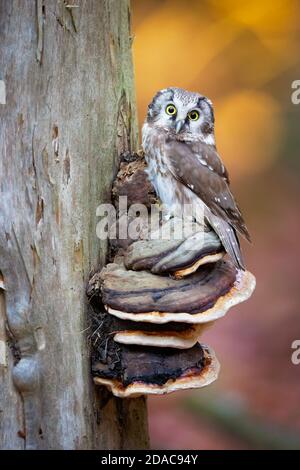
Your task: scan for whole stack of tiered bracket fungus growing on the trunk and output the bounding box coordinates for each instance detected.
[87,155,255,398]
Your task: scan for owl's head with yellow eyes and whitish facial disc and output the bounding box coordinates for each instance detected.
[146,87,214,143]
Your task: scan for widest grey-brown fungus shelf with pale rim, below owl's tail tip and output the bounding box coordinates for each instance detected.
[101,260,255,324]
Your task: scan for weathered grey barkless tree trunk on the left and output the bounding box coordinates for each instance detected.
[0,0,148,449]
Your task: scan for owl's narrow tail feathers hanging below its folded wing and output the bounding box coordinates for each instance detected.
[207,212,246,271]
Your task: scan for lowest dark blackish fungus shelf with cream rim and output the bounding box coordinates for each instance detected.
[93,344,220,398]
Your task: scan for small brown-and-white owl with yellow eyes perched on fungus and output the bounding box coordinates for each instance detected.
[142,87,250,270]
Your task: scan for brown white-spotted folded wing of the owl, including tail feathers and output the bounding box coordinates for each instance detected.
[165,140,250,269]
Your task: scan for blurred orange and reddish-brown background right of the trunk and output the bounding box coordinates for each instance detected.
[132,0,300,449]
